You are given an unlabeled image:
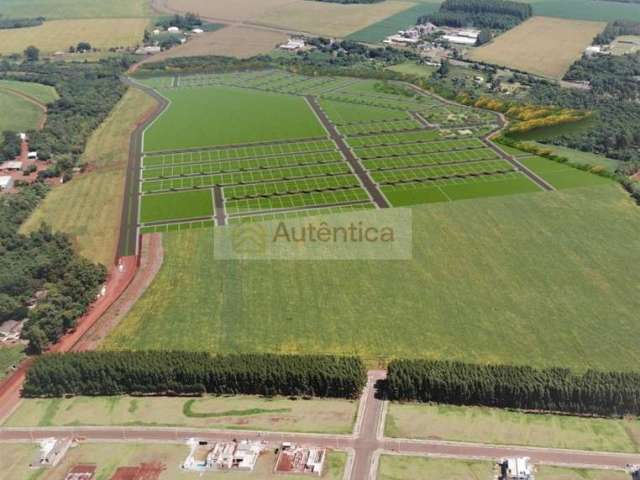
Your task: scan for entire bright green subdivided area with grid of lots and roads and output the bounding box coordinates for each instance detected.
[135,70,552,232]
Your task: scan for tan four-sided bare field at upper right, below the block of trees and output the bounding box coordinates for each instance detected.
[471,17,605,78]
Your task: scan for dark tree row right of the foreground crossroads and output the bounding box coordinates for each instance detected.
[386,360,640,415]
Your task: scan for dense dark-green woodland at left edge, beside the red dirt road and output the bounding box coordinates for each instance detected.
[0,182,106,353]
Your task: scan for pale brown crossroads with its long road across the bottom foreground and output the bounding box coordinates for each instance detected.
[0,371,640,480]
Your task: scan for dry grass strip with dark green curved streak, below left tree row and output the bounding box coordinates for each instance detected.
[0,394,357,434]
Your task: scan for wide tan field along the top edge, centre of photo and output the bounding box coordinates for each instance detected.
[167,0,417,37]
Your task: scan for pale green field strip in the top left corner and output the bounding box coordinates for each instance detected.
[0,0,151,19]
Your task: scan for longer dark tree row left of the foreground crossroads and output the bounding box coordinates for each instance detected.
[23,351,367,398]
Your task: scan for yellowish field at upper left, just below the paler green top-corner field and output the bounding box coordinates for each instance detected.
[0,18,148,54]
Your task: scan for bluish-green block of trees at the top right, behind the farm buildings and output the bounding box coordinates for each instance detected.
[418,0,533,30]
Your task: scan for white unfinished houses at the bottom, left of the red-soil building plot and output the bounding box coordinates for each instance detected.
[182,439,264,472]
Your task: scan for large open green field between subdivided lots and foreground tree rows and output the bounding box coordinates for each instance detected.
[105,184,640,369]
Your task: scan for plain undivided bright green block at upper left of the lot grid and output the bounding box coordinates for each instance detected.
[144,87,326,151]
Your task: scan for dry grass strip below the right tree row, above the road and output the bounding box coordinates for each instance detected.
[385,403,640,453]
